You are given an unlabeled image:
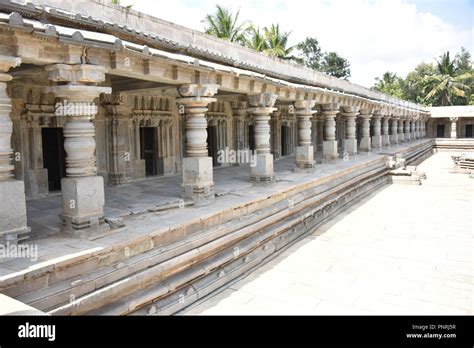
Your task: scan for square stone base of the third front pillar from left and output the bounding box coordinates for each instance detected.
[181,157,215,205]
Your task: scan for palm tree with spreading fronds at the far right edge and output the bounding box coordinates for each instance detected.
[423,52,472,106]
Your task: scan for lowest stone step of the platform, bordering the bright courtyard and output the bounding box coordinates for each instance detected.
[96,169,386,315]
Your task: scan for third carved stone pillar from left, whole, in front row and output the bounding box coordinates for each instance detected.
[176,84,219,205]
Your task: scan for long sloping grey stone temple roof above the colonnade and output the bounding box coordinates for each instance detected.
[0,0,428,112]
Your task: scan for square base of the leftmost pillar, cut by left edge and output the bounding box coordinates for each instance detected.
[0,180,30,245]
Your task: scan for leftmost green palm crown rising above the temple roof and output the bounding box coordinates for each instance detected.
[203,5,250,44]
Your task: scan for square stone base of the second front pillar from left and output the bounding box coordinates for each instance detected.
[61,176,105,231]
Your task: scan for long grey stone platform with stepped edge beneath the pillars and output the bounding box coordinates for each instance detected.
[0,140,432,315]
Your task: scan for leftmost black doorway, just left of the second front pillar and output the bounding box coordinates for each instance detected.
[41,128,66,192]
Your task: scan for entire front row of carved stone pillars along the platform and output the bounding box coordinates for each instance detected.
[0,56,430,243]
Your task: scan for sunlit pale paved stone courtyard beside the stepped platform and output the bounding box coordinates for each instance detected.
[184,152,474,315]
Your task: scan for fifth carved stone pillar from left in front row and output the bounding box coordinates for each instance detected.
[295,100,317,168]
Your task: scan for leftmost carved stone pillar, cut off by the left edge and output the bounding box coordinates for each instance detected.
[0,56,30,245]
